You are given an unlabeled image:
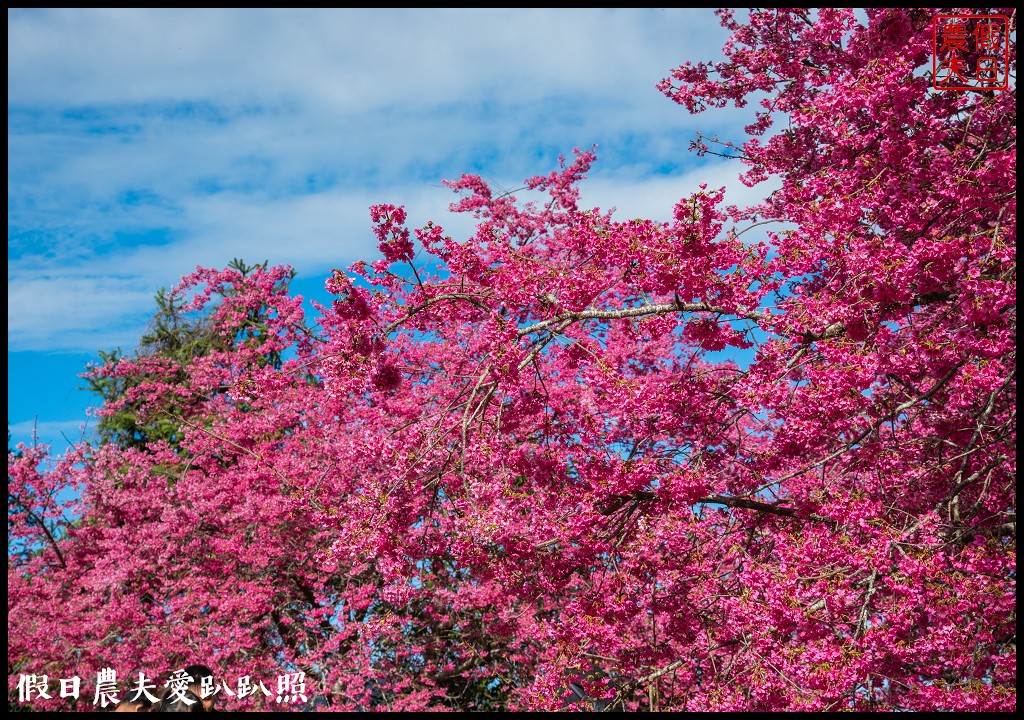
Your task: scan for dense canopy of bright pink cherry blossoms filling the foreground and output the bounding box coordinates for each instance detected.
[7,8,1017,711]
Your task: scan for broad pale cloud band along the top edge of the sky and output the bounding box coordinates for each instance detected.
[8,8,725,112]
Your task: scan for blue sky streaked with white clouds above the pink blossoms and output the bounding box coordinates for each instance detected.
[7,8,766,453]
